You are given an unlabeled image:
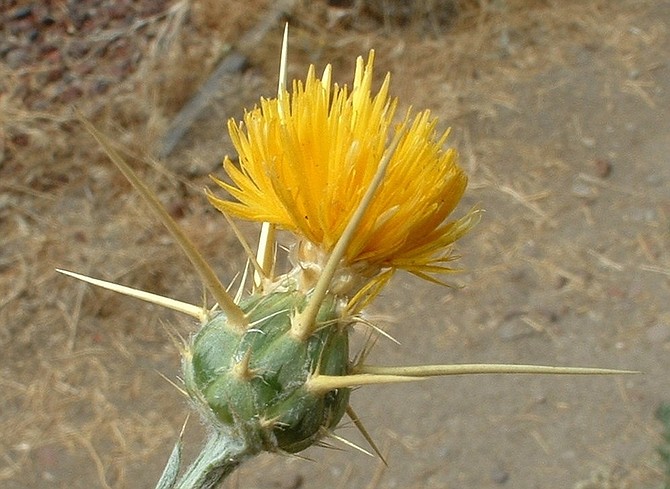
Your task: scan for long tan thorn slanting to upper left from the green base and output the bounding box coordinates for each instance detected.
[78,113,248,332]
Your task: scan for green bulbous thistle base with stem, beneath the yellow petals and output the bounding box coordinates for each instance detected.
[158,291,349,489]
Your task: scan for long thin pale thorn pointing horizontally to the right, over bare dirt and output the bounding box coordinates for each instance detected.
[354,363,640,378]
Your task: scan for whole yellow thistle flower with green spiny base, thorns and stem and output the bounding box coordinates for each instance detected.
[65,30,632,489]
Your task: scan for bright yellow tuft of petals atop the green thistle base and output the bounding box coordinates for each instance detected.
[209,51,473,290]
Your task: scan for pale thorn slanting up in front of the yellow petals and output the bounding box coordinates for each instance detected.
[291,129,405,341]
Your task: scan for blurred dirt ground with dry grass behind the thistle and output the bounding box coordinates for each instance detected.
[0,0,670,489]
